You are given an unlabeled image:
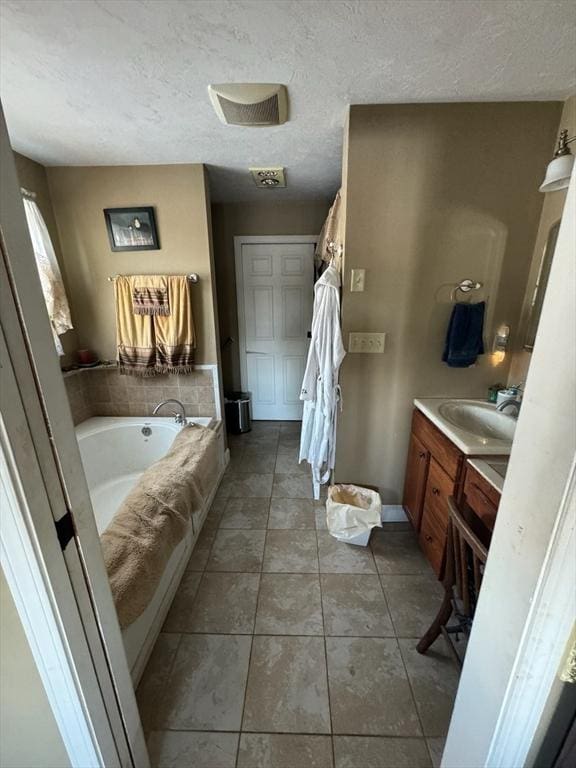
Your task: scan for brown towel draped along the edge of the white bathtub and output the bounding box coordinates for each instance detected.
[100,425,218,629]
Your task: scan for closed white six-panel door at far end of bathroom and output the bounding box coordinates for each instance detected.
[235,236,316,421]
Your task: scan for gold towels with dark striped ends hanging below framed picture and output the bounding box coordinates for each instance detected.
[114,275,196,376]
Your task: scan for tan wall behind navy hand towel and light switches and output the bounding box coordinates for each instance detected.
[336,102,561,503]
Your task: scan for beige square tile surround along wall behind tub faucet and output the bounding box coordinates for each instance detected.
[64,367,218,425]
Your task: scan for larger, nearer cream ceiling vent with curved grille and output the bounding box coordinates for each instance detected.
[208,83,288,125]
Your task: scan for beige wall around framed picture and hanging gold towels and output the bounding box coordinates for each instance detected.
[47,165,217,363]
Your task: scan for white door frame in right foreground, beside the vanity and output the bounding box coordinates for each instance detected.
[441,168,576,768]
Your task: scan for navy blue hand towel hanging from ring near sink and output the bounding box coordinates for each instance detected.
[442,301,486,368]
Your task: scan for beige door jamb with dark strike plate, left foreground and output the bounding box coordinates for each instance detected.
[0,103,149,768]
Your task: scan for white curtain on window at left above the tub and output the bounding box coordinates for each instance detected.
[24,198,72,355]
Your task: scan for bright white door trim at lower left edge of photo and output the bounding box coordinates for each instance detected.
[0,329,116,768]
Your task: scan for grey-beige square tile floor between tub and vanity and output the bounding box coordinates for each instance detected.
[137,422,458,768]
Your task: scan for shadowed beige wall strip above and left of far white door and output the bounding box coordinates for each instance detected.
[212,200,330,389]
